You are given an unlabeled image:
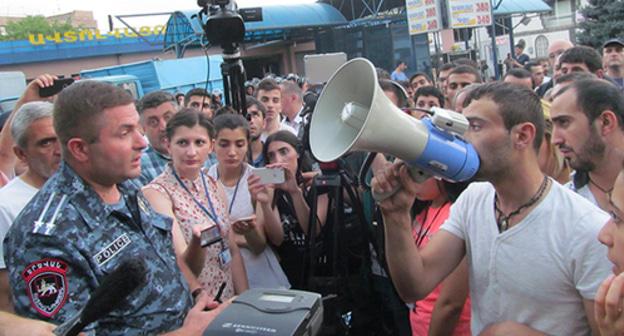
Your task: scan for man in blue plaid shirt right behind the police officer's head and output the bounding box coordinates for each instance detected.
[137,91,178,185]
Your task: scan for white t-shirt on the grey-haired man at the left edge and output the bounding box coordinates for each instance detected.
[0,177,39,269]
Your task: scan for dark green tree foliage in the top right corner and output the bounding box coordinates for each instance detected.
[577,0,624,48]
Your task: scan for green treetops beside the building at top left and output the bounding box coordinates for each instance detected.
[0,15,75,40]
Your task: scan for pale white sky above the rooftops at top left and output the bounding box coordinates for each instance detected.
[0,0,315,31]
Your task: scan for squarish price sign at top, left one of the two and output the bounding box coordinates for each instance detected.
[405,0,442,35]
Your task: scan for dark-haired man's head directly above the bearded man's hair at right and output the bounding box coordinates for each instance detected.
[555,46,604,78]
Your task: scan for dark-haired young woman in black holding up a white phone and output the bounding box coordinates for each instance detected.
[248,131,328,289]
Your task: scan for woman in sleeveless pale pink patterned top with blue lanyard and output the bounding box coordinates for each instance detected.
[143,108,248,299]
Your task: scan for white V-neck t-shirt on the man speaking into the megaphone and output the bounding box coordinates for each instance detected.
[442,180,611,335]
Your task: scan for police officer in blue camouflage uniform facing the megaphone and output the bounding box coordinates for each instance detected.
[4,81,221,335]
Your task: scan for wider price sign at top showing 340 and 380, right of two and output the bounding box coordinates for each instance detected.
[448,0,493,29]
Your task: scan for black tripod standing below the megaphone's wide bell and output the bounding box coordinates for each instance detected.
[304,168,374,335]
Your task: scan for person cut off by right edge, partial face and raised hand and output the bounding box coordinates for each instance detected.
[594,170,624,336]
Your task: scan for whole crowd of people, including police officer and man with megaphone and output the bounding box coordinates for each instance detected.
[0,35,624,336]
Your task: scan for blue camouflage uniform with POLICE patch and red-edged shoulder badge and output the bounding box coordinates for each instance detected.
[4,163,192,335]
